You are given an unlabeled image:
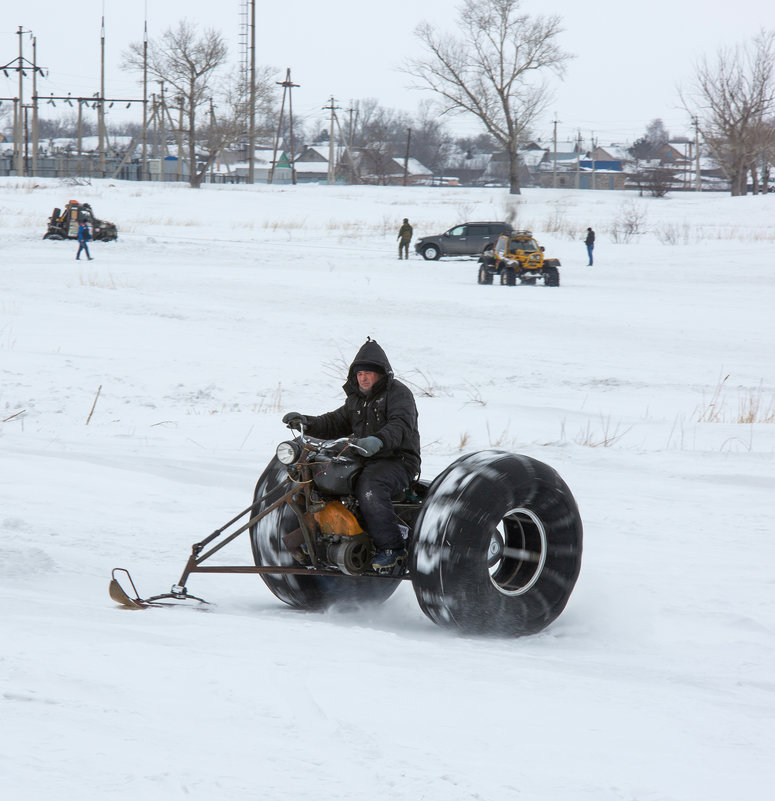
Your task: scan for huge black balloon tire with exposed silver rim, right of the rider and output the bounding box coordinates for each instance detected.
[410,450,582,637]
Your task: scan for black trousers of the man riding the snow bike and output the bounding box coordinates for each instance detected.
[355,459,409,551]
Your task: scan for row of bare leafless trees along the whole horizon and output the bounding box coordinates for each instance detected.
[118,0,775,195]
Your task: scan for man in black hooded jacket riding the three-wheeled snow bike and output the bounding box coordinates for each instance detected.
[283,338,420,571]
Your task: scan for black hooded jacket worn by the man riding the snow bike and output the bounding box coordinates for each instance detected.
[307,339,420,479]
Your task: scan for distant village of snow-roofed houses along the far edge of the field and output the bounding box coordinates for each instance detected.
[0,136,729,195]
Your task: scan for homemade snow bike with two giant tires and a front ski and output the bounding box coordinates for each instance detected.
[110,428,582,637]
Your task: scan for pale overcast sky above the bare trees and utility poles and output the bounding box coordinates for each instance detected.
[0,0,775,144]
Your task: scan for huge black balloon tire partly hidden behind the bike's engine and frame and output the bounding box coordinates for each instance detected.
[250,458,401,611]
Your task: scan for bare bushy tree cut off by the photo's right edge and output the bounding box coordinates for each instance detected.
[681,31,775,195]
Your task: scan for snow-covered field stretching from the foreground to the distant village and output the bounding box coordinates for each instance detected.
[0,179,775,801]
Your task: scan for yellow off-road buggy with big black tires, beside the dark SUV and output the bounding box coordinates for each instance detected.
[477,231,560,286]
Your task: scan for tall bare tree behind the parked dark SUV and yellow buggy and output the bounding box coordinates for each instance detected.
[404,0,571,194]
